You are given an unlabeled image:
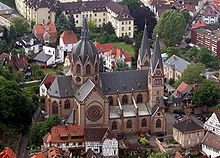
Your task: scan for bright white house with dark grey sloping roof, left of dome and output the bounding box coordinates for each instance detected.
[34,46,64,66]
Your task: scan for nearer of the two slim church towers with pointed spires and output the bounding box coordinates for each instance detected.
[148,37,164,108]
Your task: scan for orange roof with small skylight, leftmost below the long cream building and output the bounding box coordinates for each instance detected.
[34,24,57,39]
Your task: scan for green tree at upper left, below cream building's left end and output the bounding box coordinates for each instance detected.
[12,18,30,37]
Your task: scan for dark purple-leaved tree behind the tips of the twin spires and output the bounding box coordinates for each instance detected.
[132,7,157,38]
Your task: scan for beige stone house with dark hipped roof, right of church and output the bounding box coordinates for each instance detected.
[173,118,205,148]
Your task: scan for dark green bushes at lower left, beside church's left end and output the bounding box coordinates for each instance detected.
[29,115,60,147]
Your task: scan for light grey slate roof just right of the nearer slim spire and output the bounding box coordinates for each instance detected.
[164,55,190,73]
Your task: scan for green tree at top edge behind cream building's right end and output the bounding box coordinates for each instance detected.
[119,0,144,14]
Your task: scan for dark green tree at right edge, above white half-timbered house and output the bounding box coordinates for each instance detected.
[193,80,220,107]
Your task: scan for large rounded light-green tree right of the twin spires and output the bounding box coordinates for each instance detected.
[154,10,186,47]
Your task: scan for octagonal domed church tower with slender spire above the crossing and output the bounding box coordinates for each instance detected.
[71,18,99,86]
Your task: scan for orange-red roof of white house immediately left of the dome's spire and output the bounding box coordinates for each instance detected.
[60,30,78,44]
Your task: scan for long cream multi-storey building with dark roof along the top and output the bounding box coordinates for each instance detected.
[15,0,134,38]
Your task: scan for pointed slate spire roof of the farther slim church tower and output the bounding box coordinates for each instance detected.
[139,22,151,65]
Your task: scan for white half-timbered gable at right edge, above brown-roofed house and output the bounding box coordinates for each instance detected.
[204,111,220,135]
